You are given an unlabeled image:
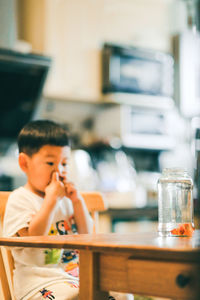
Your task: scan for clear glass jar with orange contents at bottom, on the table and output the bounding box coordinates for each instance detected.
[158,168,194,236]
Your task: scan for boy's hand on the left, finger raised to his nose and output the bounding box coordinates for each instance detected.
[45,172,65,204]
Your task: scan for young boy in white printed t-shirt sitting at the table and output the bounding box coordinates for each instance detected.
[4,120,93,300]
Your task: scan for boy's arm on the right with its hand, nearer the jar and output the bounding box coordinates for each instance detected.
[64,182,93,233]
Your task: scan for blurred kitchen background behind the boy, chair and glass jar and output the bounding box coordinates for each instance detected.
[0,0,200,232]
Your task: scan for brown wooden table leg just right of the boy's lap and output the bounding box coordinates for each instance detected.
[79,250,108,300]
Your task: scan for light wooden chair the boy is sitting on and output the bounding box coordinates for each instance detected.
[0,191,107,300]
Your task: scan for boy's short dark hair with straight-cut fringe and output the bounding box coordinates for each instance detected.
[18,120,70,156]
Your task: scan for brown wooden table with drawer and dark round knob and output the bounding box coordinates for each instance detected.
[0,231,200,300]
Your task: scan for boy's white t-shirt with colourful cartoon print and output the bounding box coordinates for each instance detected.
[3,187,78,300]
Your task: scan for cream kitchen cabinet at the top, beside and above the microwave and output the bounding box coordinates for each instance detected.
[18,0,177,101]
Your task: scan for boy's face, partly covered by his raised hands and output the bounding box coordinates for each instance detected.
[21,145,70,196]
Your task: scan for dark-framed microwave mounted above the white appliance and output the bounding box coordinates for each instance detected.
[102,43,174,97]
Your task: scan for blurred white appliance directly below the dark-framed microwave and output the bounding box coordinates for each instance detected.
[94,105,176,150]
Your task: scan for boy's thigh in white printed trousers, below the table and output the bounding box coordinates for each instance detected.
[29,282,79,300]
